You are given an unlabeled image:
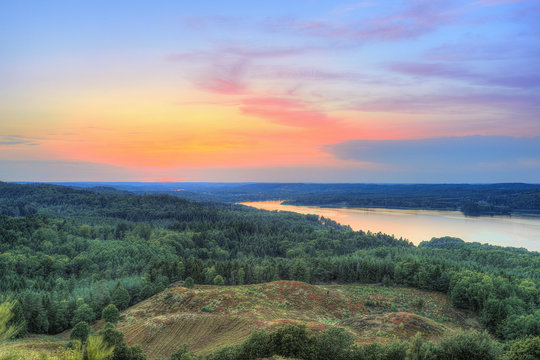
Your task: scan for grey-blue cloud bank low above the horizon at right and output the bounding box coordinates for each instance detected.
[323,135,540,182]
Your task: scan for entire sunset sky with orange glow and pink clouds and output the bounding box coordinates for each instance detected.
[0,0,540,183]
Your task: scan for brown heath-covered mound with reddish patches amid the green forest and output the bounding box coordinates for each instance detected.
[114,281,479,358]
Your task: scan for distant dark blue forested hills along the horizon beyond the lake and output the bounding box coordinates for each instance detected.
[50,183,540,216]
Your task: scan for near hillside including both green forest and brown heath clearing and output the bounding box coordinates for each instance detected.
[0,183,540,359]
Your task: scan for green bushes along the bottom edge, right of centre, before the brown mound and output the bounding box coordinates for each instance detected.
[208,325,510,360]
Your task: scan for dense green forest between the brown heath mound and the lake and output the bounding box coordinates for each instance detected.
[0,183,540,359]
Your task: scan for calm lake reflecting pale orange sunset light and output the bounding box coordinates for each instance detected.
[241,201,540,251]
